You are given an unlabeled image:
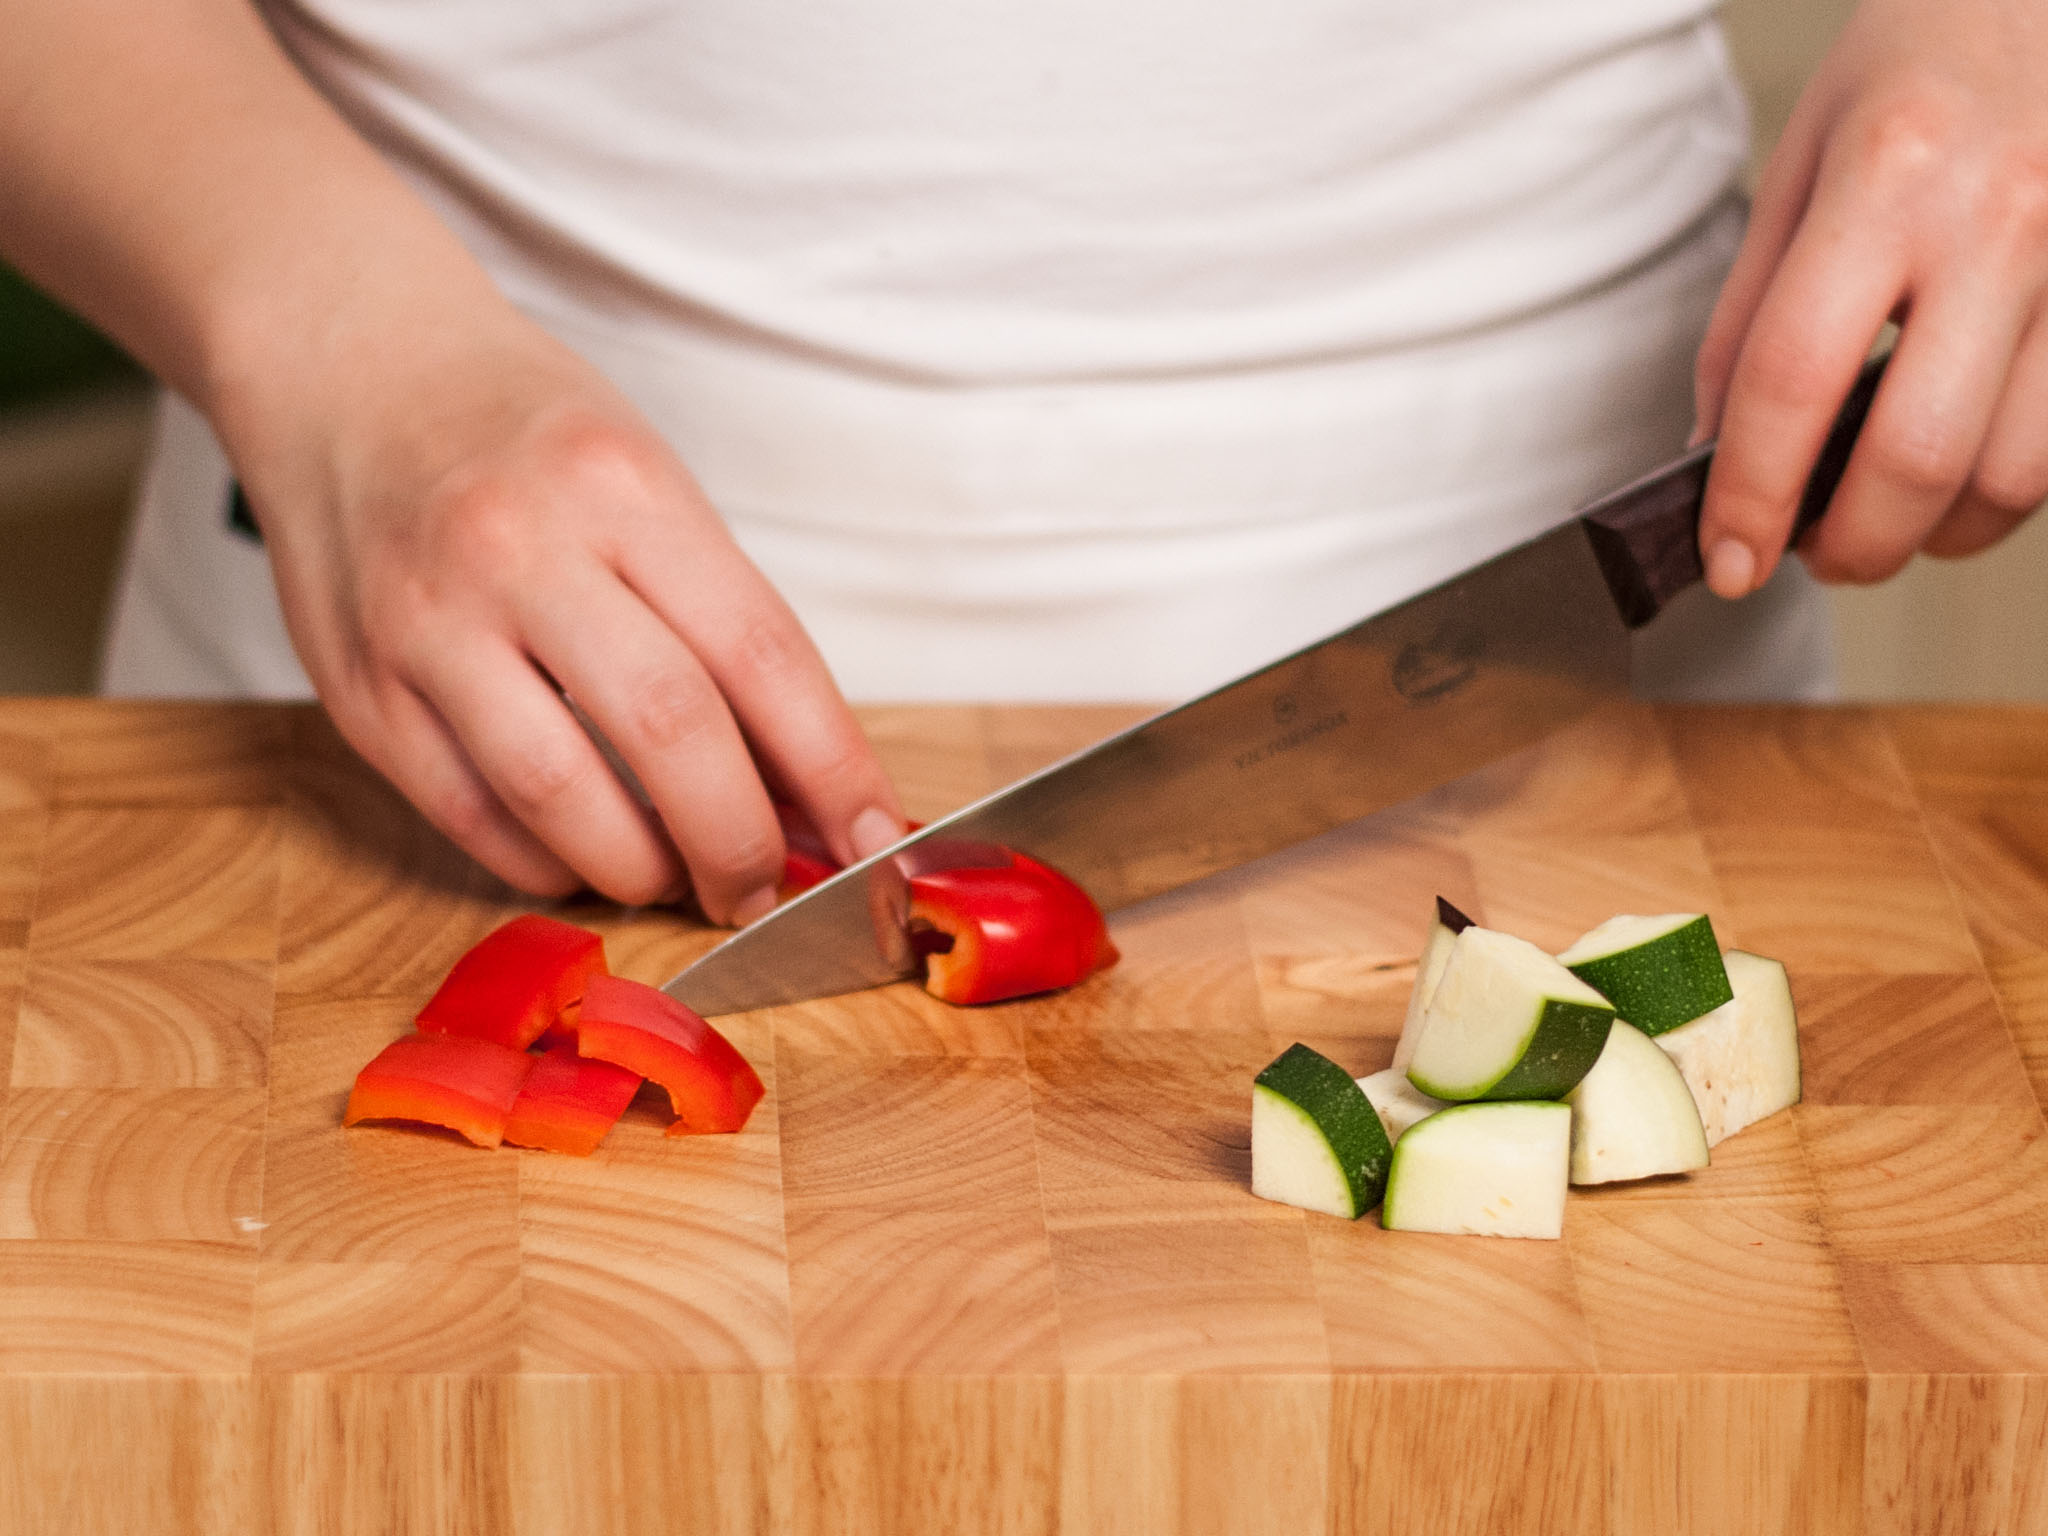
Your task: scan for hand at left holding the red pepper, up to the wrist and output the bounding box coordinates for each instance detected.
[223,307,903,924]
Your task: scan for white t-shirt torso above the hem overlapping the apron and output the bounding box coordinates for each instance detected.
[270,0,1743,383]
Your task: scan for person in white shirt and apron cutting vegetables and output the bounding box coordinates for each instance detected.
[0,0,2048,922]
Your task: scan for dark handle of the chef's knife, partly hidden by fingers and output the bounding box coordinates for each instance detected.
[1579,352,1892,629]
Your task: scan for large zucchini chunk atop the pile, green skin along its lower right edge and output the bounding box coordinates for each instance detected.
[1407,928,1614,1100]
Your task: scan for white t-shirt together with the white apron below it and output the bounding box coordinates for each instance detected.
[109,0,1825,698]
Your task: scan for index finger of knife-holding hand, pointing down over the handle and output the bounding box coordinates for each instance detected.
[1700,169,1907,598]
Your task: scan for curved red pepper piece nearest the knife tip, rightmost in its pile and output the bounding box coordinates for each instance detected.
[575,977,764,1135]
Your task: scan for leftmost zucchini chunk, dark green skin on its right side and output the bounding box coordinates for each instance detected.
[1251,1044,1393,1221]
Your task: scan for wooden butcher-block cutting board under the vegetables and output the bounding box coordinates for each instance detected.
[0,702,2048,1536]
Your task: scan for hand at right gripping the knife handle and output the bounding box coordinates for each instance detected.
[1698,0,2048,598]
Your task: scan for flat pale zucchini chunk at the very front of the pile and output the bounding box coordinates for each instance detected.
[1380,1102,1571,1237]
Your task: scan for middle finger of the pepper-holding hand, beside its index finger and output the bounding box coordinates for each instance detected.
[522,567,782,922]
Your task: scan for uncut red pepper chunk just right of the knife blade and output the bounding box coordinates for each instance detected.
[909,852,1118,1004]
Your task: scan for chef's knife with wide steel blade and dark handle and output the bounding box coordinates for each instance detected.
[666,358,1884,1014]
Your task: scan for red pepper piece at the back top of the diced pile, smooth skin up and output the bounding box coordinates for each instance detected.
[420,911,604,1051]
